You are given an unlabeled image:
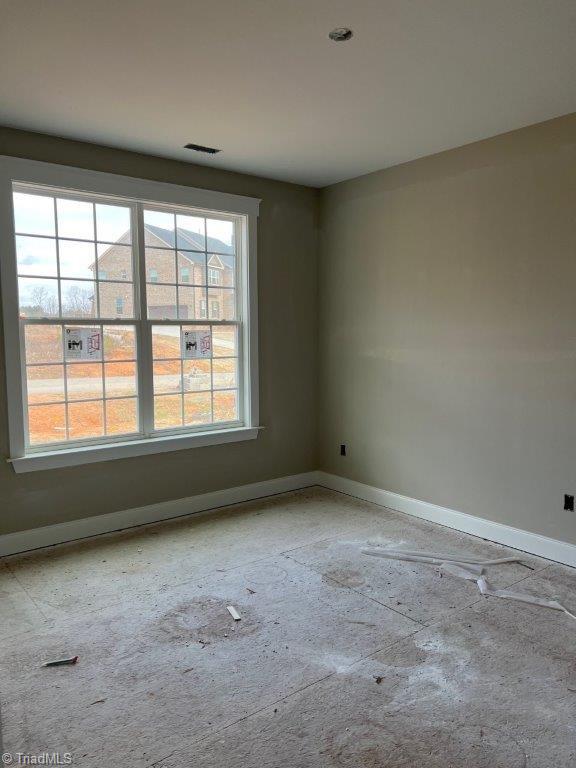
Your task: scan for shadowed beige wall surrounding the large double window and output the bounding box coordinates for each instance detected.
[0,128,318,534]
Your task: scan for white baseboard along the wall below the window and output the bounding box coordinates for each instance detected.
[0,472,318,557]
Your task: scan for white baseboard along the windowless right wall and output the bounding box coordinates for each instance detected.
[316,472,576,567]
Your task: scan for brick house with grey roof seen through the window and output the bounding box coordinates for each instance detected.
[91,224,235,320]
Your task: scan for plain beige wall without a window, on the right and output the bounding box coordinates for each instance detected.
[319,115,576,543]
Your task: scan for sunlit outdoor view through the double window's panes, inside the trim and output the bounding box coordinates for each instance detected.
[13,184,243,449]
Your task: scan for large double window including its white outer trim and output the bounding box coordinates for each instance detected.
[0,160,257,471]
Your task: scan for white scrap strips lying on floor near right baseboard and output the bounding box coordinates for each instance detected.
[362,548,576,619]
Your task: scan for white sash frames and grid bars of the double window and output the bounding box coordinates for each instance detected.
[12,182,247,453]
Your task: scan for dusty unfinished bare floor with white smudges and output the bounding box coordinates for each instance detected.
[0,488,576,768]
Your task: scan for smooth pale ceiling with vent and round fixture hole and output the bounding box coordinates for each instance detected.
[0,0,576,186]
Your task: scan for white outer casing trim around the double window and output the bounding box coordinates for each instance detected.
[0,157,260,472]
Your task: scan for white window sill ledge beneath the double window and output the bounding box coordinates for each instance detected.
[8,427,261,474]
